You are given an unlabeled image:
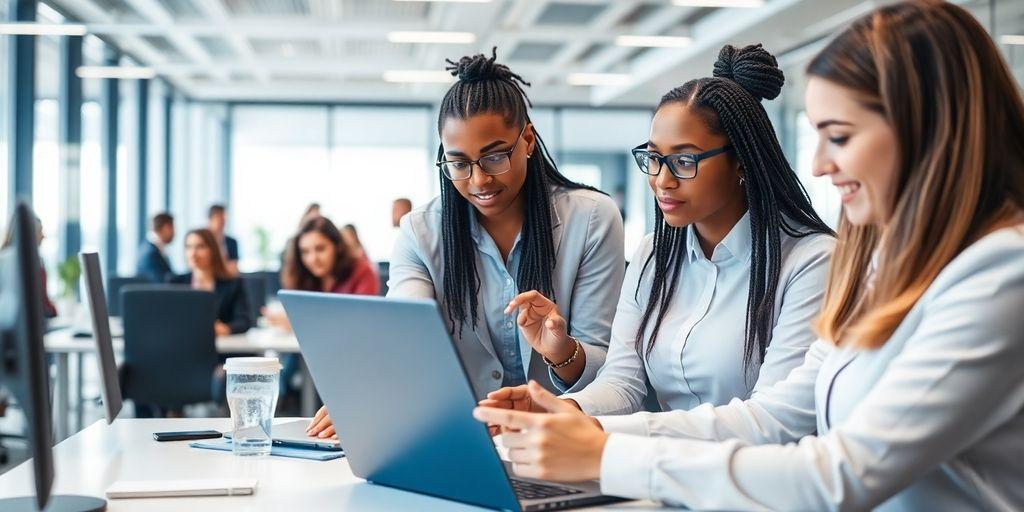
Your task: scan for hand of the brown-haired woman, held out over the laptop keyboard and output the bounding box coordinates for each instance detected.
[473,381,608,482]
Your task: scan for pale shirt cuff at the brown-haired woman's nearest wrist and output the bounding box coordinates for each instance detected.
[601,433,657,500]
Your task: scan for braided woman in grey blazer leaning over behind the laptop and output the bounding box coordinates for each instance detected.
[309,51,626,436]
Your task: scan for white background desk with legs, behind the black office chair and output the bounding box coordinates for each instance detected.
[44,327,315,439]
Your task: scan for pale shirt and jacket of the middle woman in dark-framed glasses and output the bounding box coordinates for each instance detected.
[564,213,836,415]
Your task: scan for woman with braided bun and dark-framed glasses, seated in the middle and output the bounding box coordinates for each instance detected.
[482,45,835,415]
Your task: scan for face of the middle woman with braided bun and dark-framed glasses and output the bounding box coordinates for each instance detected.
[647,101,743,227]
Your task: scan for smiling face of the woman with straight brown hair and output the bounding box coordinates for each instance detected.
[805,77,898,226]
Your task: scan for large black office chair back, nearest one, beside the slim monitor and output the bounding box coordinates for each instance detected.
[121,285,219,411]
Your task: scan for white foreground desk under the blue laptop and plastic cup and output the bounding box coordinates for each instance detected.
[0,418,656,512]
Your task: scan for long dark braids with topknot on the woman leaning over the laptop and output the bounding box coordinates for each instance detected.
[437,47,594,332]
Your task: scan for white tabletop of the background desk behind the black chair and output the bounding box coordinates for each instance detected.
[44,327,299,353]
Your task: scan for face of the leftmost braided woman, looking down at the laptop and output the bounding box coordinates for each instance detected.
[440,113,536,218]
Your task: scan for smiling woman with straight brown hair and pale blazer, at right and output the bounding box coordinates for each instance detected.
[474,1,1024,510]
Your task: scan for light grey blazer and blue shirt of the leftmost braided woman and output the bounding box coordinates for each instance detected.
[387,186,626,398]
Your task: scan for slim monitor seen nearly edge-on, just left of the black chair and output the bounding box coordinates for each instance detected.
[79,253,122,425]
